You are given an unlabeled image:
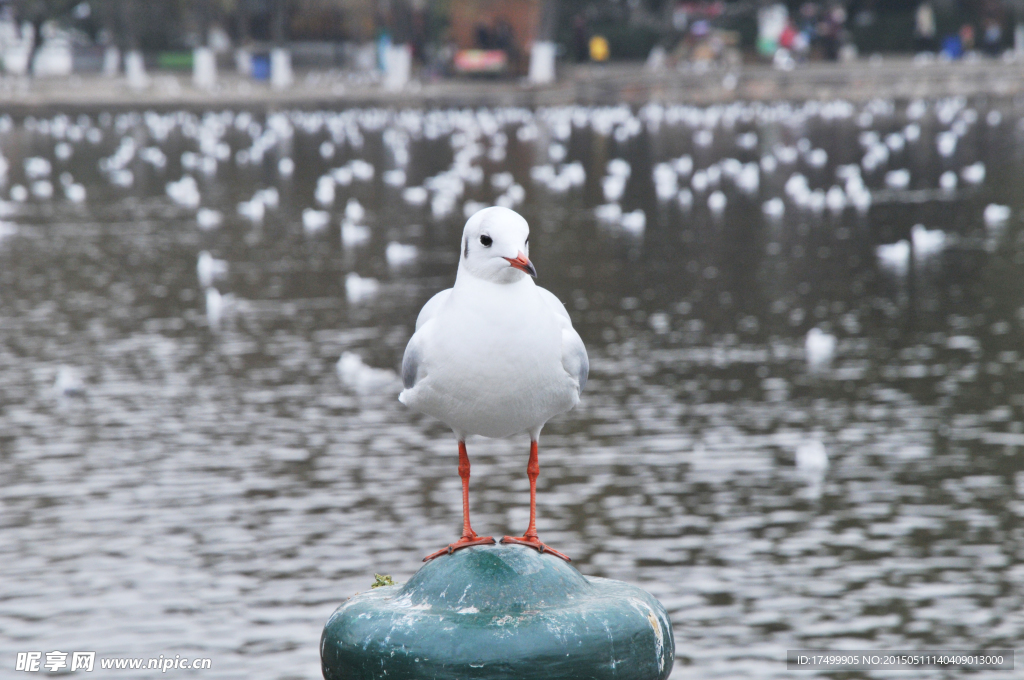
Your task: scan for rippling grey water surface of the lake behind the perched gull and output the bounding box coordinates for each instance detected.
[0,99,1024,678]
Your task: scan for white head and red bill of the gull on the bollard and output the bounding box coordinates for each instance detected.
[459,207,537,284]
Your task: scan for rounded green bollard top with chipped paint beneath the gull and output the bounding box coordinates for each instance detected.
[321,545,675,680]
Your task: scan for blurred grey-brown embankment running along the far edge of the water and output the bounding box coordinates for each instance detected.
[0,57,1024,116]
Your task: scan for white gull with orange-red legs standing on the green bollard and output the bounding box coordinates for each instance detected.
[398,207,590,561]
